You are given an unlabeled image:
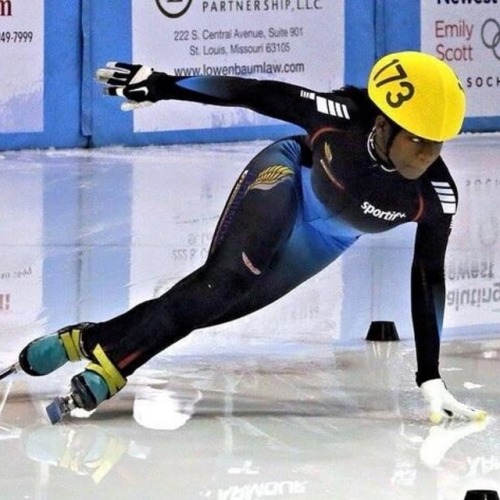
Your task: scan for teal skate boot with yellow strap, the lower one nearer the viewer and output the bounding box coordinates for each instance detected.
[46,345,127,424]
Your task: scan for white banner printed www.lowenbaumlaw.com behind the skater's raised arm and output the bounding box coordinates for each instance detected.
[132,0,344,132]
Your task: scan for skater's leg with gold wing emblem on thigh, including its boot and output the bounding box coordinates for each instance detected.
[47,140,302,409]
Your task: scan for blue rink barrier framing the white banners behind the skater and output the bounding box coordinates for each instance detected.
[0,0,500,150]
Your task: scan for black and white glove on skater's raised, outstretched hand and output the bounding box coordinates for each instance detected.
[96,62,168,111]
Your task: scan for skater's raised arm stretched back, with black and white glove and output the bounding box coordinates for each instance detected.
[97,63,350,132]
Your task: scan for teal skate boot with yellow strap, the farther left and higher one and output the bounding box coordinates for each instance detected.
[19,323,94,376]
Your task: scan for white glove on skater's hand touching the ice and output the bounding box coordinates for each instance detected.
[420,378,487,424]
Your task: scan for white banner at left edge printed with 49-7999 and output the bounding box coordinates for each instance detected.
[0,0,44,133]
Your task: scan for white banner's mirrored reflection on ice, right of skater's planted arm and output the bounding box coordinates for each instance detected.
[446,136,500,327]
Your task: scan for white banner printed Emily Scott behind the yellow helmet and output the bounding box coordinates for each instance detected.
[421,0,500,117]
